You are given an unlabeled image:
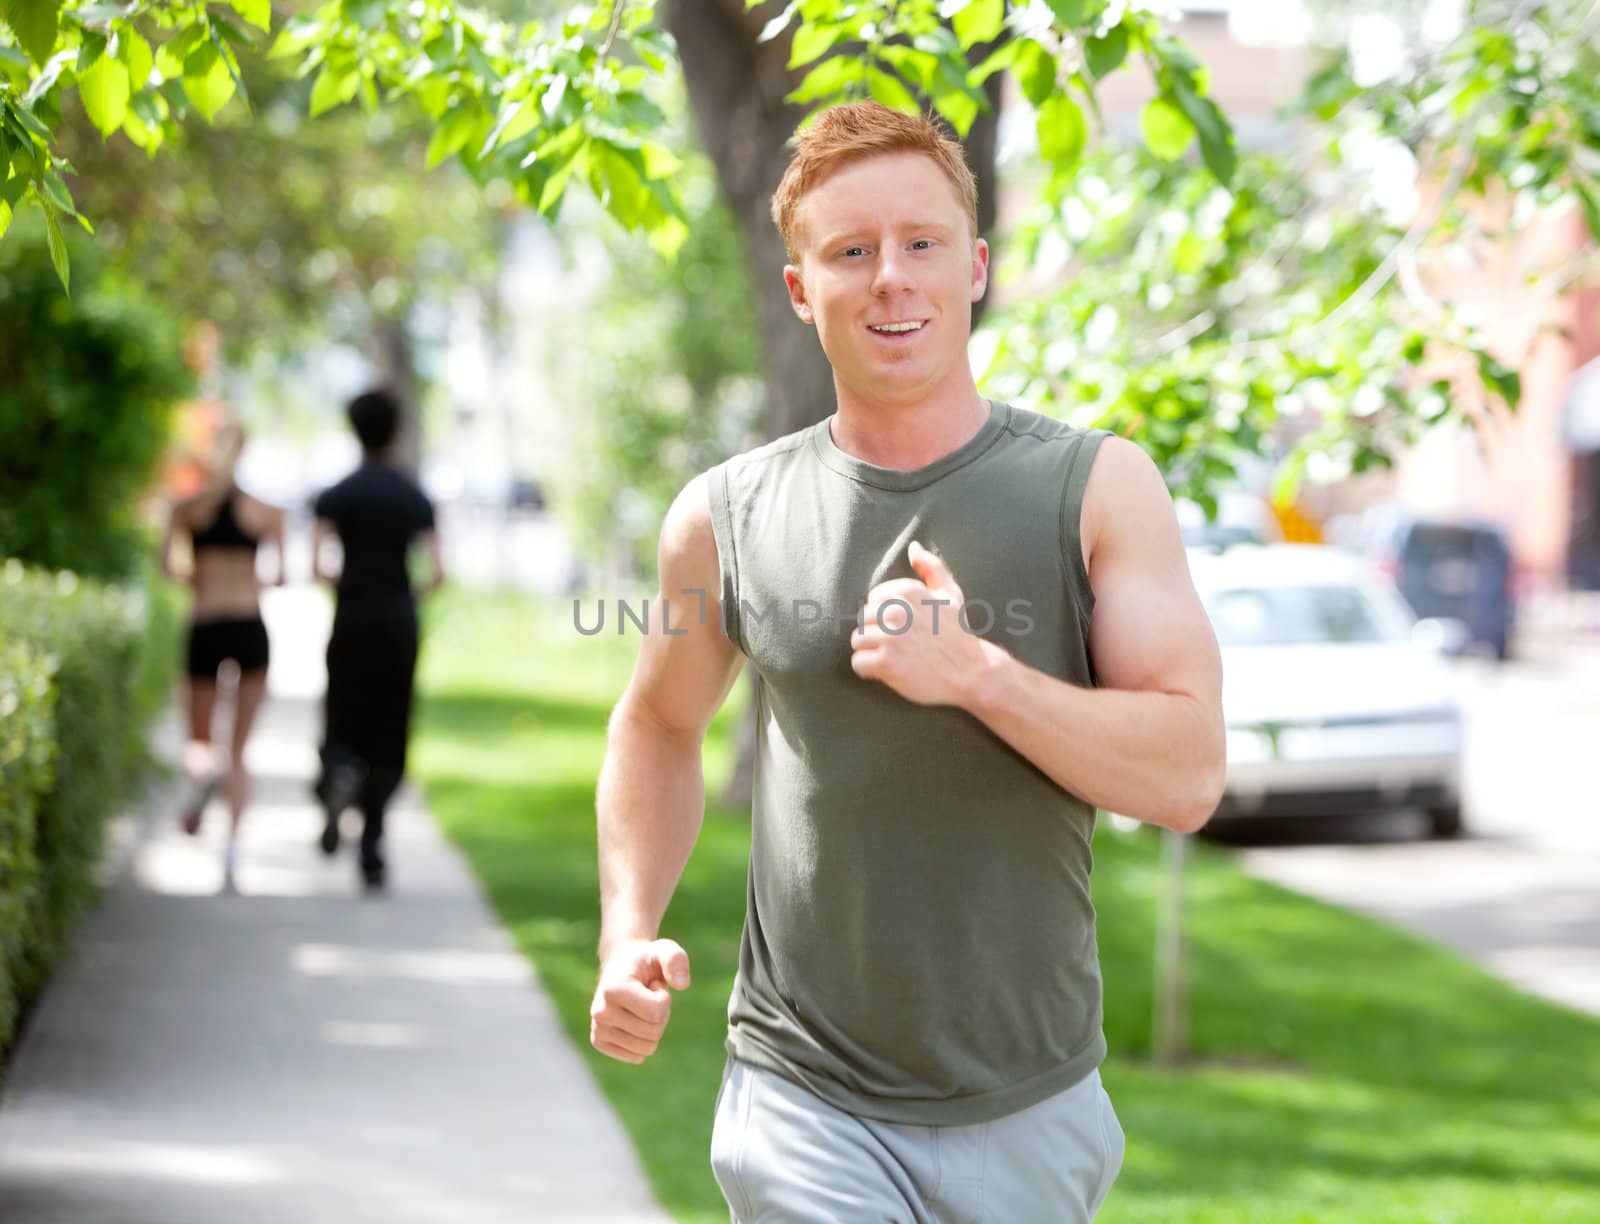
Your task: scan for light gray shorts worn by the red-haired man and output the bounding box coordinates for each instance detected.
[710,1059,1123,1224]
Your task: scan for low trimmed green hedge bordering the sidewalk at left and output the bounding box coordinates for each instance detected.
[0,560,179,1050]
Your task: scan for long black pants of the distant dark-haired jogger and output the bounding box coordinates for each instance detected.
[322,600,418,859]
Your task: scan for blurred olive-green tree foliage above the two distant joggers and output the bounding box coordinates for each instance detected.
[56,50,510,358]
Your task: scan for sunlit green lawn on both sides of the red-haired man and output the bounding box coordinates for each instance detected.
[414,594,1600,1224]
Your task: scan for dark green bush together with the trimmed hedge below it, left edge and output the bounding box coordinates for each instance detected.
[0,208,192,1053]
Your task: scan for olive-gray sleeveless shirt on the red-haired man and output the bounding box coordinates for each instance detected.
[709,403,1106,1125]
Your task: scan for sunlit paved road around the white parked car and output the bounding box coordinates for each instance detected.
[1227,645,1600,1014]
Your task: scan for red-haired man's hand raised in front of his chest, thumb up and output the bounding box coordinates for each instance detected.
[850,541,998,706]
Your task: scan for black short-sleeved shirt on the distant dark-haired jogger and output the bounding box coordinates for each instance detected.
[312,462,434,605]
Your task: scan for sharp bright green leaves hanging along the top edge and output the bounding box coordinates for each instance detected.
[0,0,1234,281]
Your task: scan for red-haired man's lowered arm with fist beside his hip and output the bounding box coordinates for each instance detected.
[590,478,741,1062]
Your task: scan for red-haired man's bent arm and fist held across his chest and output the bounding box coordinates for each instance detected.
[856,438,1226,832]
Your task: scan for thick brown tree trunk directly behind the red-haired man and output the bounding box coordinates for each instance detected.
[661,0,1000,805]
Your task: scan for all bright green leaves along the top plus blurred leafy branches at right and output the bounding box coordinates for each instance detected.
[0,0,1600,496]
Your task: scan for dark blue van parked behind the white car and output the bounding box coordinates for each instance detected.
[1373,517,1514,659]
